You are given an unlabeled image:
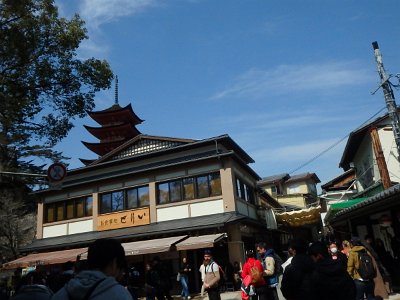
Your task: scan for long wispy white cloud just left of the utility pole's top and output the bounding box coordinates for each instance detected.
[211,62,375,99]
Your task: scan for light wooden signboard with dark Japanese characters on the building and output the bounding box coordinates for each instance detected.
[97,207,150,231]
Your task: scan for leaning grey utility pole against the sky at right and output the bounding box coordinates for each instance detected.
[372,42,400,160]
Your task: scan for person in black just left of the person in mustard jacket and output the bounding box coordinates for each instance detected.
[308,242,356,300]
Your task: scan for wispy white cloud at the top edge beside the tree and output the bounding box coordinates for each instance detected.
[80,0,157,28]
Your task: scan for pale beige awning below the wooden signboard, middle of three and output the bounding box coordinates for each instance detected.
[122,235,187,255]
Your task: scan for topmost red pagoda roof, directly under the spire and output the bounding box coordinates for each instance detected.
[88,103,143,125]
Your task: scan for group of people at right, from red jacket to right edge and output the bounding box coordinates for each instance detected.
[241,236,399,300]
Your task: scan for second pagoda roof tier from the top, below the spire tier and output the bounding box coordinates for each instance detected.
[83,123,140,141]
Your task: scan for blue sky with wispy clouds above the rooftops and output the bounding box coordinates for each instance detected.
[56,0,400,188]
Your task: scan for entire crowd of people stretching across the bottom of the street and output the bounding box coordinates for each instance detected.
[0,236,398,300]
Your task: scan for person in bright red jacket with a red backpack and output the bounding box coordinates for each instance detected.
[242,250,268,300]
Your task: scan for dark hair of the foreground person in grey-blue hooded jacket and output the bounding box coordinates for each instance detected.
[87,239,126,270]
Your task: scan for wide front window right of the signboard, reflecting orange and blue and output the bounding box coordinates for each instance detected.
[157,172,222,204]
